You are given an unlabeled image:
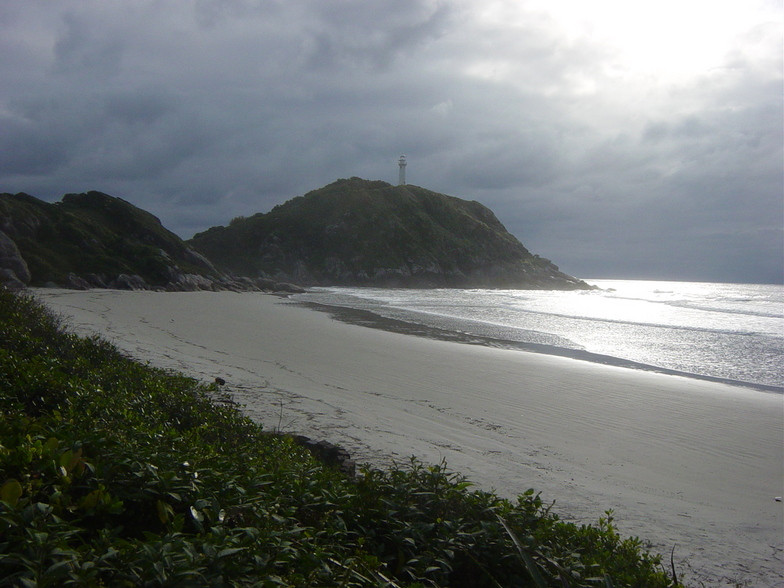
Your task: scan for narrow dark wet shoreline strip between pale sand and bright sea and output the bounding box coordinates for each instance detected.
[289,298,784,395]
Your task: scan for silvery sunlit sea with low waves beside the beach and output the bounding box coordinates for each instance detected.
[295,279,784,393]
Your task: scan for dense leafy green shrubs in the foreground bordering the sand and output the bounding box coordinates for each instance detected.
[0,290,677,588]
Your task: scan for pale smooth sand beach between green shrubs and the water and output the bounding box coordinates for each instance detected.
[36,290,784,586]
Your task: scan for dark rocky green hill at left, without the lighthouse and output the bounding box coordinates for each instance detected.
[0,192,254,290]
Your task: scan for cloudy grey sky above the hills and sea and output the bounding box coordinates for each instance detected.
[0,0,784,283]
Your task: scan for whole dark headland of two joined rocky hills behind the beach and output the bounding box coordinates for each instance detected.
[0,178,590,292]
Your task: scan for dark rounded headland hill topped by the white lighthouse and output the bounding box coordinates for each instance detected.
[188,178,589,289]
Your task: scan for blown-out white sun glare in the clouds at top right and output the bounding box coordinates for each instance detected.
[472,0,782,79]
